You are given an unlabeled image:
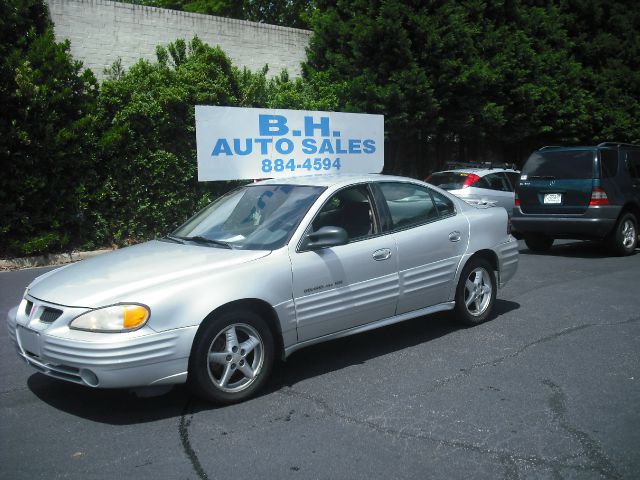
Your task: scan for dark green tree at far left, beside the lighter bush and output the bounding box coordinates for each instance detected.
[0,0,96,254]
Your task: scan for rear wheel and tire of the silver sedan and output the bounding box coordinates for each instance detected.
[453,258,497,325]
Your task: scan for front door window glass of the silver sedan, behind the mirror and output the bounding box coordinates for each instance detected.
[311,185,377,242]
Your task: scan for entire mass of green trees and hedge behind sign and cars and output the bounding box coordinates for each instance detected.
[0,0,640,256]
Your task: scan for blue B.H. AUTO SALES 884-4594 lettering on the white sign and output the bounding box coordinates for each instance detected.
[211,114,376,173]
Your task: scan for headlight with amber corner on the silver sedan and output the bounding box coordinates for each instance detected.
[69,303,151,333]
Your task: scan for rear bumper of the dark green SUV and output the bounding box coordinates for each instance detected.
[511,206,620,238]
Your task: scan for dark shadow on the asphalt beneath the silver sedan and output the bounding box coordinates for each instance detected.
[27,299,520,425]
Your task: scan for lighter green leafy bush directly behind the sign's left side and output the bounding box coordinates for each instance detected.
[93,37,276,244]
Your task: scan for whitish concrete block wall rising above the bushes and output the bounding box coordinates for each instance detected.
[47,0,311,79]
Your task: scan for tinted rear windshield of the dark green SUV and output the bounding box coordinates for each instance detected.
[522,150,594,179]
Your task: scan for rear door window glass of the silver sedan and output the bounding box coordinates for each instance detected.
[379,182,439,230]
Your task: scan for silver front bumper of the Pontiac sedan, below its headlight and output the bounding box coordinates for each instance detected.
[7,304,197,388]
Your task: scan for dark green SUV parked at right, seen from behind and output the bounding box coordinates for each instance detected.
[512,142,640,255]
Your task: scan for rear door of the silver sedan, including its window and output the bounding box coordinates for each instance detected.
[376,182,469,314]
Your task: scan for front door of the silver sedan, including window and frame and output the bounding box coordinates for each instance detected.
[290,184,398,342]
